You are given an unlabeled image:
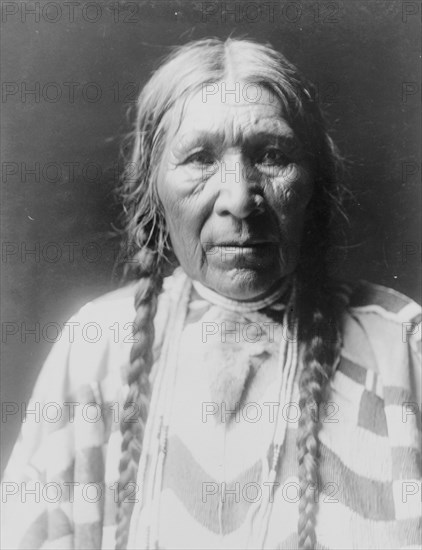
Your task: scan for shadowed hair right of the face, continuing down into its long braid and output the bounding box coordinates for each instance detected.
[296,67,347,550]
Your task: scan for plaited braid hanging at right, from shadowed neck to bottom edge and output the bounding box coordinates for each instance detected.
[297,280,341,549]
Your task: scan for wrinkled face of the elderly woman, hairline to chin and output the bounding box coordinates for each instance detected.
[157,82,313,300]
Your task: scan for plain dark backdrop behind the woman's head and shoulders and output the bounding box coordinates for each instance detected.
[1,0,421,474]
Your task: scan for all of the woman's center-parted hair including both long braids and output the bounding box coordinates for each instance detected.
[116,38,342,550]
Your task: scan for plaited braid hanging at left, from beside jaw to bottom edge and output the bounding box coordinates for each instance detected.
[116,248,163,550]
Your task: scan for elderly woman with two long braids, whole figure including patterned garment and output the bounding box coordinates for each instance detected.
[3,39,420,549]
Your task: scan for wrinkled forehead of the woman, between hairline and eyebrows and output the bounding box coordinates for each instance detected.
[170,82,294,144]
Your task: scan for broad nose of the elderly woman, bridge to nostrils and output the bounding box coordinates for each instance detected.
[214,155,264,219]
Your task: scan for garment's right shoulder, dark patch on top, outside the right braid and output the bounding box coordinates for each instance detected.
[339,281,421,402]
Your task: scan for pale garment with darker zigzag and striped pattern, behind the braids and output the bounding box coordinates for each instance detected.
[2,269,421,549]
